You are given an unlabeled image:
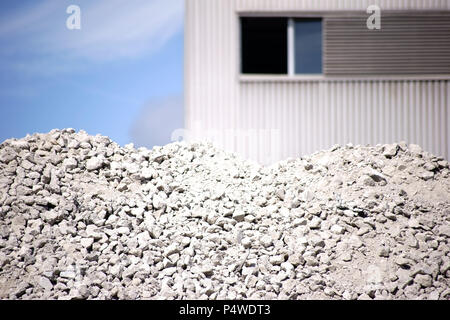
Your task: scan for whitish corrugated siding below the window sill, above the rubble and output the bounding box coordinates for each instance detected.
[239,80,450,163]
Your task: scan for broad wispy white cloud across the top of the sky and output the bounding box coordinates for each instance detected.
[0,0,183,61]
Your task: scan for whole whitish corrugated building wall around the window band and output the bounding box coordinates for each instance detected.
[185,0,450,164]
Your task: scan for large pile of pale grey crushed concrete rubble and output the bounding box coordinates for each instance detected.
[0,129,450,299]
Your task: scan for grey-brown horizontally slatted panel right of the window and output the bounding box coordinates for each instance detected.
[324,13,450,75]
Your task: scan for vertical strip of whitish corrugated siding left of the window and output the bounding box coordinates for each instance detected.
[184,0,239,149]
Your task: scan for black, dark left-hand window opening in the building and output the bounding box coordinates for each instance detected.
[241,17,287,74]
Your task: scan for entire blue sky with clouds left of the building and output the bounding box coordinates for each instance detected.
[0,0,184,147]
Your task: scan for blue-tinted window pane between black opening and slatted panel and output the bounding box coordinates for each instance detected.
[295,18,322,73]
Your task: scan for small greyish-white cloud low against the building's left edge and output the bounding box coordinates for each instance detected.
[130,96,184,148]
